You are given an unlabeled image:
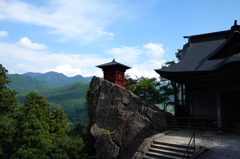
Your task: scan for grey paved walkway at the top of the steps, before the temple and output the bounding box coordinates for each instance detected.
[156,129,240,159]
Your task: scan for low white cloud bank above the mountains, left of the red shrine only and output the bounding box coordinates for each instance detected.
[0,40,111,76]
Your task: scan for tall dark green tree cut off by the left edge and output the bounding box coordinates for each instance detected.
[0,64,19,159]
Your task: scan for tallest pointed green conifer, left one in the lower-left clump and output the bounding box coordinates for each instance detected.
[13,92,52,158]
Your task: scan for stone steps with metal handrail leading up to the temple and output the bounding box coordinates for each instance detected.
[143,141,195,159]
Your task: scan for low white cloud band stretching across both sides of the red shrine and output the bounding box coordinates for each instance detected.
[0,39,165,78]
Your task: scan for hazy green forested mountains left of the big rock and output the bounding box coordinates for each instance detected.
[7,72,92,123]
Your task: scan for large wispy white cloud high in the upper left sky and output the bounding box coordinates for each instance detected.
[0,0,127,43]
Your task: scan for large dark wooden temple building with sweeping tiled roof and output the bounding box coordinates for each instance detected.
[155,21,240,132]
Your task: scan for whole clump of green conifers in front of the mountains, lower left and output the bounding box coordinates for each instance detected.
[12,92,88,159]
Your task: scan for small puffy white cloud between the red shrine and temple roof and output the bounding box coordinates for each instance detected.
[143,42,164,58]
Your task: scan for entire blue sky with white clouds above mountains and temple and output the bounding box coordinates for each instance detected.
[0,0,240,77]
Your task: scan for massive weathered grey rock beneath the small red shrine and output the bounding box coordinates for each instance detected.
[87,77,167,159]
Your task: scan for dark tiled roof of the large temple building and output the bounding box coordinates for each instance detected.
[155,26,240,75]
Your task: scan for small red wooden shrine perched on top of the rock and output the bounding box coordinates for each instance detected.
[96,59,130,87]
